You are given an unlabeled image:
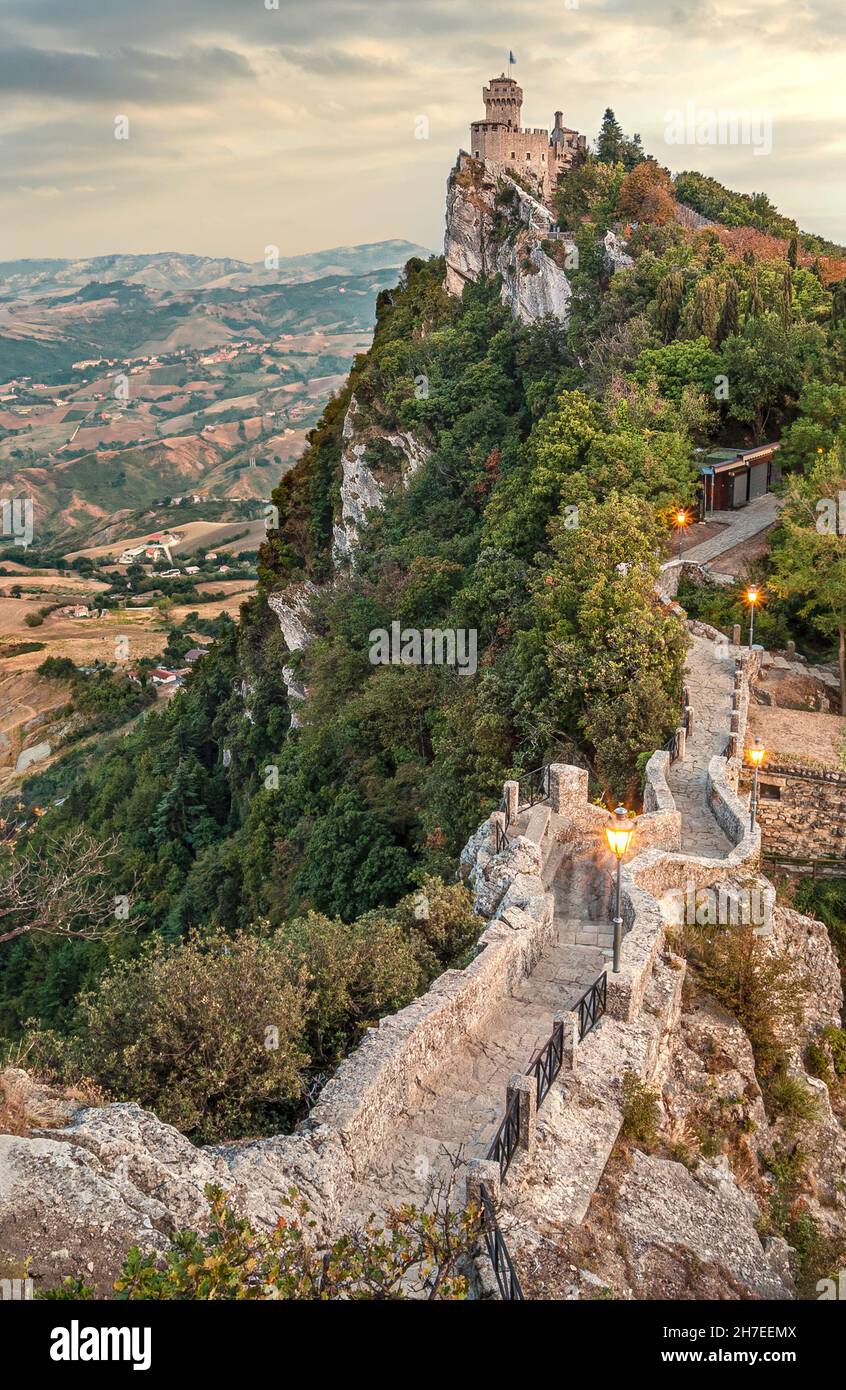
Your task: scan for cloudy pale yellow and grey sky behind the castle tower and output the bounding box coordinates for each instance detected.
[0,0,846,260]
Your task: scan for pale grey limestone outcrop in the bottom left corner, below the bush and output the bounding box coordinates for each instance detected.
[0,1104,349,1295]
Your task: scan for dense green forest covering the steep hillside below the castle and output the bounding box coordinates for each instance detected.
[0,127,846,1137]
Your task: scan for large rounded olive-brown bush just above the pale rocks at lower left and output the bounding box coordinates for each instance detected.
[37,933,308,1143]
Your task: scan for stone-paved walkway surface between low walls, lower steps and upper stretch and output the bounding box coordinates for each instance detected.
[337,637,733,1225]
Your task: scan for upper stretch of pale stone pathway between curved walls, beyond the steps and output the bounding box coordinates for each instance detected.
[667,637,735,859]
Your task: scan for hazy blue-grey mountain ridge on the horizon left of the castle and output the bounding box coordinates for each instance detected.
[0,240,432,299]
